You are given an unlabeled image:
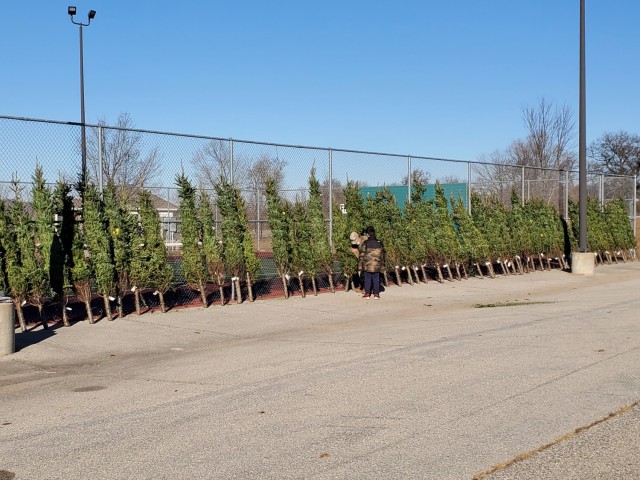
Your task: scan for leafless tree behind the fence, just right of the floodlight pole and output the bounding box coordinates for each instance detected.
[87,113,161,192]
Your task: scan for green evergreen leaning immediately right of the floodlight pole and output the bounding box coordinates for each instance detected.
[82,184,118,321]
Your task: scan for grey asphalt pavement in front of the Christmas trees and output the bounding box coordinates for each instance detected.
[0,262,640,480]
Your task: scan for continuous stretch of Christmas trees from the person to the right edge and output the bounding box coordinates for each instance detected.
[333,179,636,285]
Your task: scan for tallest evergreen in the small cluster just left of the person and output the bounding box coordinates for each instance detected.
[307,168,335,294]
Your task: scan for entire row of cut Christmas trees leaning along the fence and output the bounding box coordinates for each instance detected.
[0,167,636,330]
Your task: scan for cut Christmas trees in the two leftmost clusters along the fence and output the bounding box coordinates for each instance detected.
[0,167,259,331]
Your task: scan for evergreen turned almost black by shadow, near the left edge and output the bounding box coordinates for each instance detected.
[49,181,74,327]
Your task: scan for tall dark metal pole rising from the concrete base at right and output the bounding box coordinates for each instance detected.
[578,0,587,252]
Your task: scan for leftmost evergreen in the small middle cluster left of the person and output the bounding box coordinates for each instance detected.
[265,177,291,298]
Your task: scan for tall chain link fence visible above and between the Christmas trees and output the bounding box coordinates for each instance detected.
[0,116,636,318]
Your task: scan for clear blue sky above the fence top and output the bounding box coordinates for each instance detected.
[0,0,640,160]
